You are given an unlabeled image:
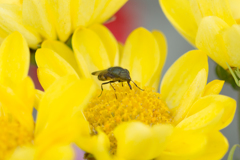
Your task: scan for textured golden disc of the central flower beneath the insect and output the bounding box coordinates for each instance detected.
[84,83,172,154]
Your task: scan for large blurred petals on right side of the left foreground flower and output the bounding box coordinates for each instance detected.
[10,75,94,160]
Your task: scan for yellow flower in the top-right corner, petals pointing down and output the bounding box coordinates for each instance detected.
[159,0,240,69]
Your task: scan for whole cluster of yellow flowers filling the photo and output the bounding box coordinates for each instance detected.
[0,0,237,160]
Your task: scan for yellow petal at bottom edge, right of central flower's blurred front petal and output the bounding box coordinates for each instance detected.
[157,130,207,160]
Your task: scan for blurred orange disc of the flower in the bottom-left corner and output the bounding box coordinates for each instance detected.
[0,116,33,160]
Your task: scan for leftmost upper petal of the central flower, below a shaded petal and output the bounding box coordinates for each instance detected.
[35,48,78,77]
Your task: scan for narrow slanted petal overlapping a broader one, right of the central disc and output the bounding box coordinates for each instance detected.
[173,69,207,124]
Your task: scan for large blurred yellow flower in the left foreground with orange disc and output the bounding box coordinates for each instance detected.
[0,32,94,160]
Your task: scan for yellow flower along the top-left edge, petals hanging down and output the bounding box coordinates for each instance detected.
[0,0,127,49]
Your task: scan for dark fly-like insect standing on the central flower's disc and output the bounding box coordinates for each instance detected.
[92,67,144,98]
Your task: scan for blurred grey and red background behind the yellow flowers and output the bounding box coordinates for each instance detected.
[30,0,240,160]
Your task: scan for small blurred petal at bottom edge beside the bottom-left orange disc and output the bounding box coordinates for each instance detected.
[9,146,36,160]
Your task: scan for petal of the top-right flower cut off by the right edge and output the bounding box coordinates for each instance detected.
[220,25,240,67]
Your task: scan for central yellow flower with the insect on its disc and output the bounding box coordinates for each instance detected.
[36,25,236,160]
